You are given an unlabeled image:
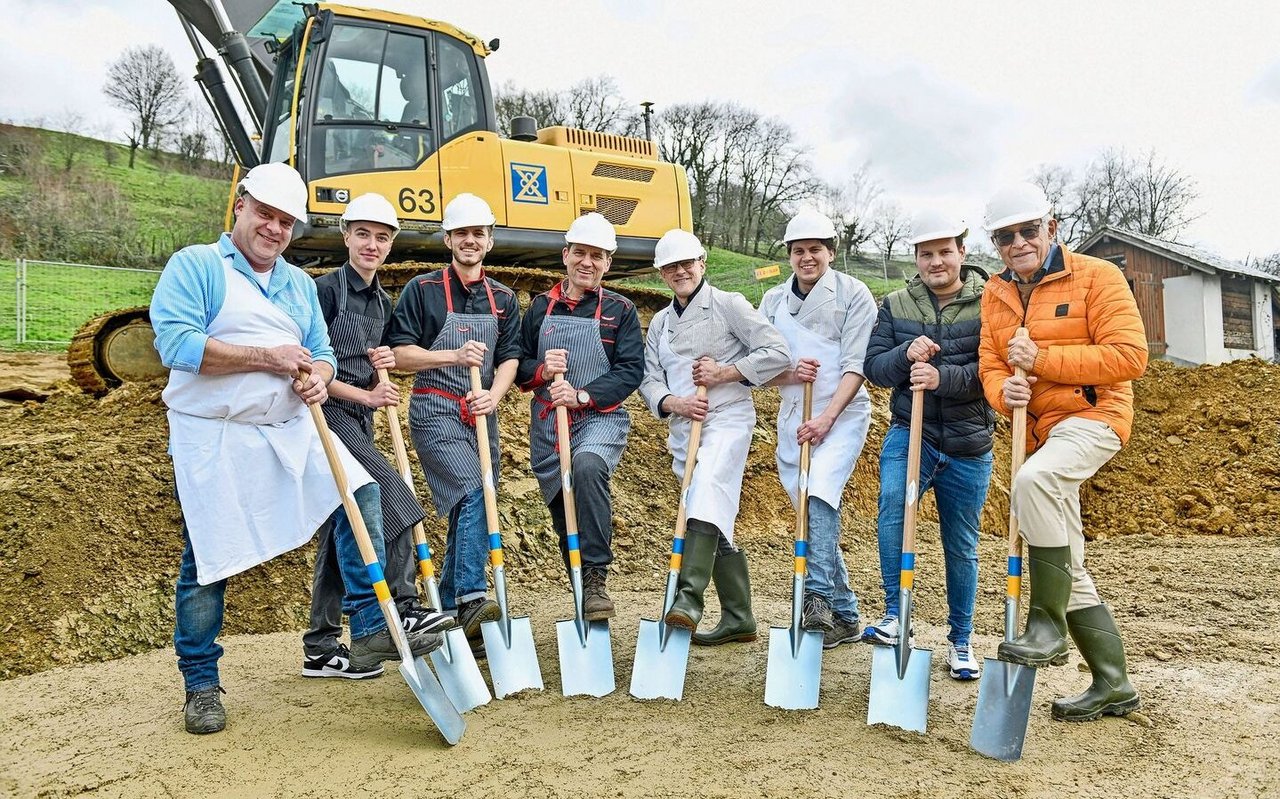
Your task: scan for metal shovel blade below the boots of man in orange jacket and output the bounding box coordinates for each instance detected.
[969,658,1036,762]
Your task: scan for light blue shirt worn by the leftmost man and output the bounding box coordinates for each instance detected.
[151,233,338,374]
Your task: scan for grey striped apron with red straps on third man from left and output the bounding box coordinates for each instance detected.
[408,269,498,516]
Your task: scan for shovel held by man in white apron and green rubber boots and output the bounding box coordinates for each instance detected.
[631,385,707,702]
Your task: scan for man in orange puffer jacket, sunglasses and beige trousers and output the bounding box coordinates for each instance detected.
[978,183,1147,721]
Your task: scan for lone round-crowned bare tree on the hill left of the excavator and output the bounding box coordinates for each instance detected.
[102,45,187,168]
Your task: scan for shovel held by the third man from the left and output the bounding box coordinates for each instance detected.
[471,366,543,699]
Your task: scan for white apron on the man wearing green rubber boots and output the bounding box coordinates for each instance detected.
[658,314,755,542]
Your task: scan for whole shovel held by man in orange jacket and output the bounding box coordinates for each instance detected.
[969,328,1036,761]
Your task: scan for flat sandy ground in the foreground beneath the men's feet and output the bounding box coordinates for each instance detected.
[0,537,1280,798]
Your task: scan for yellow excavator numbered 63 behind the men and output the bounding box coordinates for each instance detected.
[68,0,691,393]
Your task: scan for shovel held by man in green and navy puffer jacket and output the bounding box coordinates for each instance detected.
[867,388,933,732]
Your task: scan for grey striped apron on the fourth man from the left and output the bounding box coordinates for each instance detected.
[529,288,631,504]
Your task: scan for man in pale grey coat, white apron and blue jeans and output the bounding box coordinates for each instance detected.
[760,210,876,649]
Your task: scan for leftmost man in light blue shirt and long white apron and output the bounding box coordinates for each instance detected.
[151,164,387,734]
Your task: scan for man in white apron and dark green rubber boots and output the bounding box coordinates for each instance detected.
[640,229,791,645]
